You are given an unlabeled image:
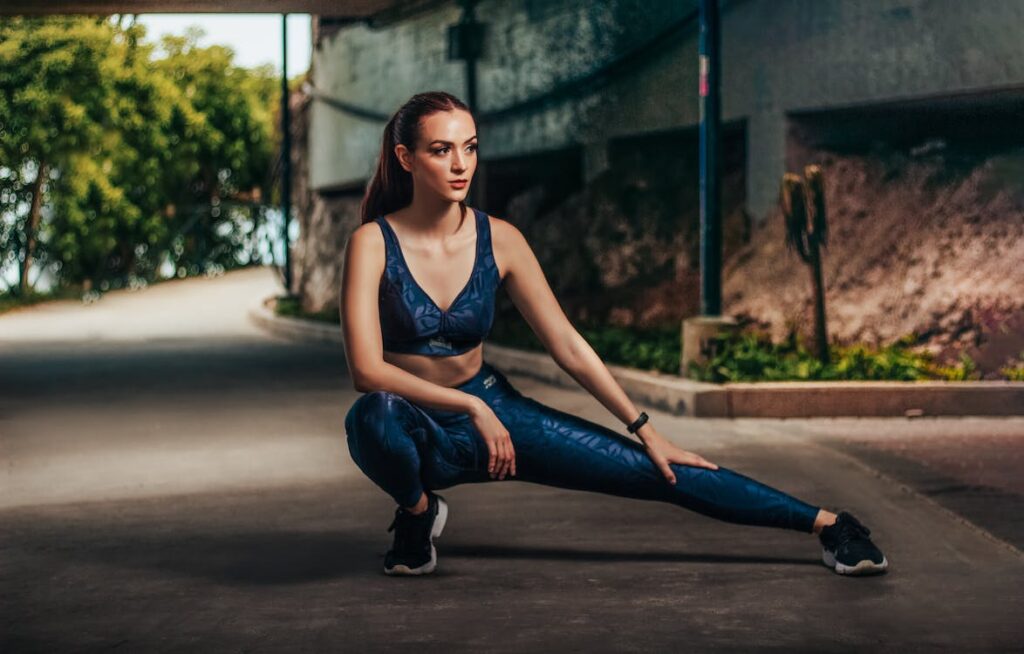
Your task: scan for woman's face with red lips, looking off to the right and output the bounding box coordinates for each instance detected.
[395,110,476,202]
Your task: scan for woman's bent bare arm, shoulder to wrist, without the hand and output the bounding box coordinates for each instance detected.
[338,222,483,415]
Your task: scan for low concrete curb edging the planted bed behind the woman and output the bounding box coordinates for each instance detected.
[249,301,1024,418]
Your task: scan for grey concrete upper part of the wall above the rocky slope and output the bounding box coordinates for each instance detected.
[308,0,1024,217]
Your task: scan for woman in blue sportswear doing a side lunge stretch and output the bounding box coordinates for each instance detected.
[340,92,888,574]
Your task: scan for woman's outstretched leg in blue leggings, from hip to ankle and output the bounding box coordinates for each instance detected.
[496,396,818,533]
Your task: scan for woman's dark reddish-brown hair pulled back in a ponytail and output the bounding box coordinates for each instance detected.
[359,91,469,223]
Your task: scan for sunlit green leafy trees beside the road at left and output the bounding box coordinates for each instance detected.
[0,16,279,292]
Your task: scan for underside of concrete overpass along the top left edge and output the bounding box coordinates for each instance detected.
[0,0,411,18]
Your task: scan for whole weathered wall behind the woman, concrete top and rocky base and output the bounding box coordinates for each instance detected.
[297,0,1024,369]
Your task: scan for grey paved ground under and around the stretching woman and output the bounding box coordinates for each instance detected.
[0,270,1024,652]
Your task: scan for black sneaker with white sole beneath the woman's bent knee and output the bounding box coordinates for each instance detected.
[384,490,447,574]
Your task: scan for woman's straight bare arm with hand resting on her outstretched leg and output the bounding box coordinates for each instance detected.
[493,219,718,483]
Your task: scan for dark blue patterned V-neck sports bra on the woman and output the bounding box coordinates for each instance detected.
[376,208,505,356]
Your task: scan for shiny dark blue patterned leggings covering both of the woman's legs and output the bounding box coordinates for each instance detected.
[345,362,818,533]
